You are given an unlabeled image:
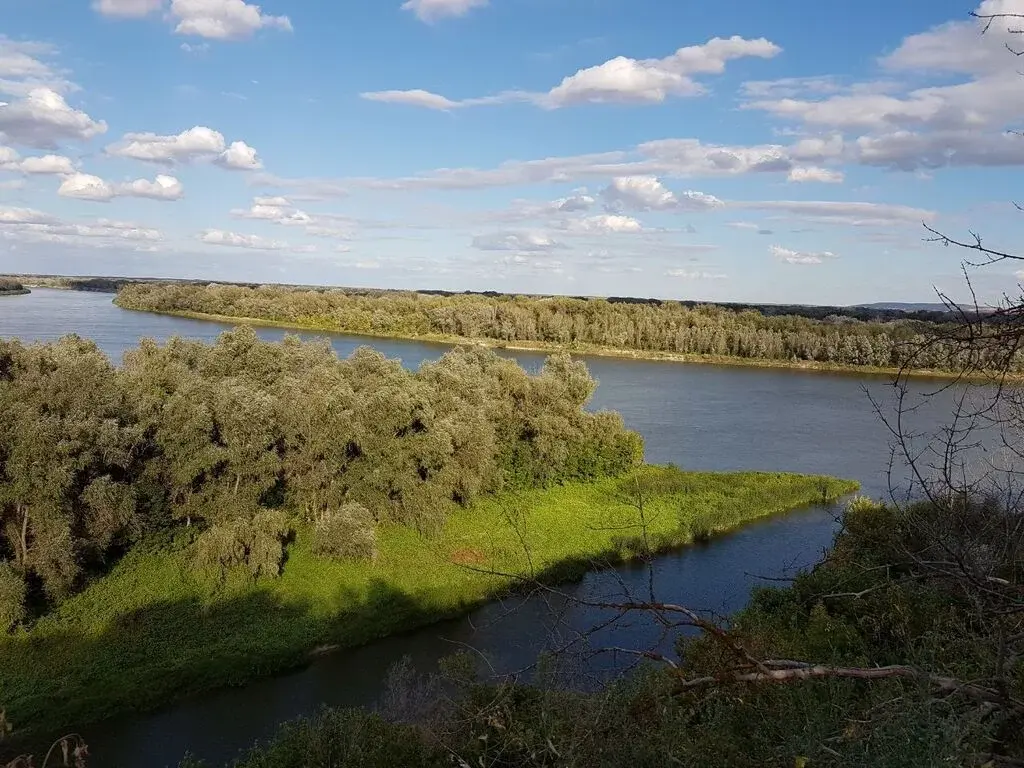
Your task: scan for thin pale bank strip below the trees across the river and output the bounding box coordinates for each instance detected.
[114,300,999,381]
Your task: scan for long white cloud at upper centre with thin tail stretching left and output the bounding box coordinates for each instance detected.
[361,36,782,110]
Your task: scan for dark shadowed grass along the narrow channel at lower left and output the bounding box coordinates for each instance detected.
[0,580,438,764]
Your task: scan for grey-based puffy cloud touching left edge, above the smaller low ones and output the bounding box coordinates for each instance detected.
[0,88,106,150]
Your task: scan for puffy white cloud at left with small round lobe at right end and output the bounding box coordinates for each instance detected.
[105,125,263,171]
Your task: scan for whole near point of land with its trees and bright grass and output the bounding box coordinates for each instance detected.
[0,329,854,732]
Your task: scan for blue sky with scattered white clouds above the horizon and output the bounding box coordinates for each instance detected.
[0,0,1024,304]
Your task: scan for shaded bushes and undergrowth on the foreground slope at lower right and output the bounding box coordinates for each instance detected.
[182,500,1024,768]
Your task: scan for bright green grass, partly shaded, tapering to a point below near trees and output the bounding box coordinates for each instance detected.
[0,467,857,737]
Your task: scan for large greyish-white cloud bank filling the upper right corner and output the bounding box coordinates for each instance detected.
[743,0,1024,171]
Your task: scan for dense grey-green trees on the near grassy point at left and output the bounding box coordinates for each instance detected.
[0,329,643,631]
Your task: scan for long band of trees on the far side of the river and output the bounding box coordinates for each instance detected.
[117,284,1007,371]
